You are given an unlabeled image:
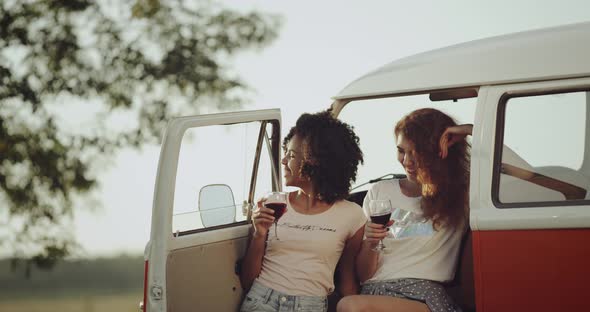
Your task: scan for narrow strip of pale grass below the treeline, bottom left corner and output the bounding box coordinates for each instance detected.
[0,292,142,312]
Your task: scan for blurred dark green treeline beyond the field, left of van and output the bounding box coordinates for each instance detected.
[0,256,144,298]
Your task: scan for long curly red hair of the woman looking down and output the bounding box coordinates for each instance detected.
[395,108,469,228]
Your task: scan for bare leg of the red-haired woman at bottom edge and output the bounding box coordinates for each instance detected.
[336,295,430,312]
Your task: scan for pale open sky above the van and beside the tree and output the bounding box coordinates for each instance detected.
[73,0,590,257]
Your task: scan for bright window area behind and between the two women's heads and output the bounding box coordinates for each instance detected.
[338,94,477,191]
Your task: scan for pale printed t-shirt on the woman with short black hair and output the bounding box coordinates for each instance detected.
[257,196,366,296]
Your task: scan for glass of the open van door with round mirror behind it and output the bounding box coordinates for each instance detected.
[172,122,270,233]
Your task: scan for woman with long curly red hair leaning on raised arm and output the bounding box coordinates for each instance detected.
[338,108,469,312]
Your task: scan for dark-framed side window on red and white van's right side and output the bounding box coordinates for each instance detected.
[492,91,590,208]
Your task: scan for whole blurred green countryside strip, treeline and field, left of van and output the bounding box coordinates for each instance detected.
[0,256,143,312]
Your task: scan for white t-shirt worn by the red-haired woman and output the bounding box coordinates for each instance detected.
[363,179,465,283]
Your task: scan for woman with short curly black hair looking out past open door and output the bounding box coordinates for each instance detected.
[240,111,366,311]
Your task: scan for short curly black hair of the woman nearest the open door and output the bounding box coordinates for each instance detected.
[283,111,363,204]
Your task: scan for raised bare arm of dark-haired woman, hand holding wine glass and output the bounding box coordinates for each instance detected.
[240,201,274,290]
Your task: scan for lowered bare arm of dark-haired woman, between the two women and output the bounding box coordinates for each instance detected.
[338,227,365,297]
